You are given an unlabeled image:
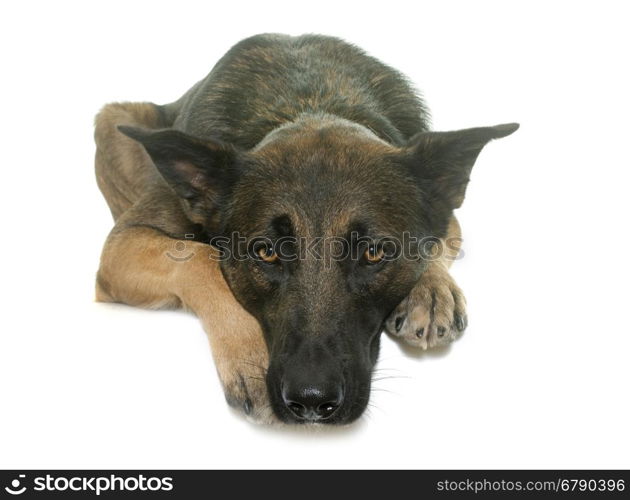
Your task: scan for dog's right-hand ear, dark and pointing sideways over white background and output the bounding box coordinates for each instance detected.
[407,123,519,235]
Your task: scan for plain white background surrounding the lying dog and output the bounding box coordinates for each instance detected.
[0,0,630,468]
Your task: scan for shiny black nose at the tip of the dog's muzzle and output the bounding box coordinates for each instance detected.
[282,381,343,422]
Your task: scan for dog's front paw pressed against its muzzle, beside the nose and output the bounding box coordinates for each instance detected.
[219,362,277,424]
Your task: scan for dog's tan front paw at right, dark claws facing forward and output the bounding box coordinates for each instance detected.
[385,268,468,349]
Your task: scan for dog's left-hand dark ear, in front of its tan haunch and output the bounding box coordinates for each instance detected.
[118,125,236,224]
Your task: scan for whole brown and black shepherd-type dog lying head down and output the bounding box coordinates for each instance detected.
[95,34,518,424]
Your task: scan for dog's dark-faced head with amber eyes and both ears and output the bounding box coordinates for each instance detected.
[121,117,518,423]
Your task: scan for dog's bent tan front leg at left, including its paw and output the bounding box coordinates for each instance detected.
[96,223,274,422]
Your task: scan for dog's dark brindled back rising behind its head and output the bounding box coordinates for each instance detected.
[164,34,428,149]
